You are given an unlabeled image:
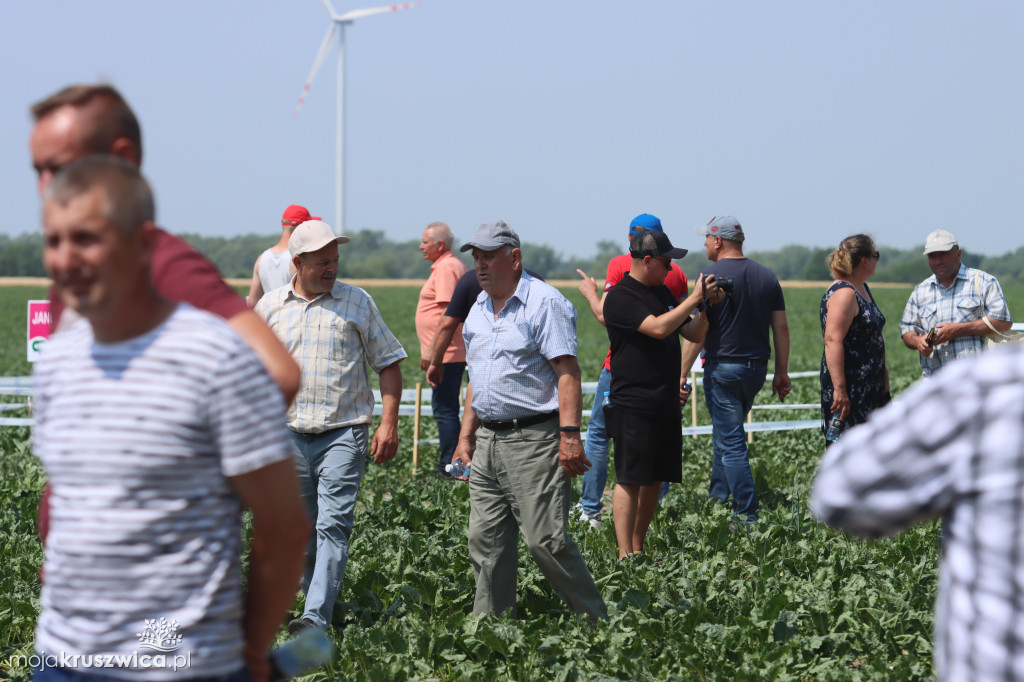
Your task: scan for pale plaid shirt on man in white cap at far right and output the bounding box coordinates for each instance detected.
[899,264,1010,377]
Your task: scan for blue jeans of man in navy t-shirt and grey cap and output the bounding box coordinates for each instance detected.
[703,360,768,521]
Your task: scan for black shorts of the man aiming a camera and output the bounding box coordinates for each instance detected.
[604,404,683,485]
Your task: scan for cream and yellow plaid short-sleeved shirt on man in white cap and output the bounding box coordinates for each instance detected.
[255,279,408,433]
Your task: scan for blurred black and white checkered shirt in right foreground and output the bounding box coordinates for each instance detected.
[811,343,1024,682]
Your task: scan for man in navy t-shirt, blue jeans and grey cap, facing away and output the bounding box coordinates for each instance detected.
[696,216,792,523]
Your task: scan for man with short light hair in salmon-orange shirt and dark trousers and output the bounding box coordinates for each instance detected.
[416,222,466,480]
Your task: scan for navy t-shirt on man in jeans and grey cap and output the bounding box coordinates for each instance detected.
[700,258,785,361]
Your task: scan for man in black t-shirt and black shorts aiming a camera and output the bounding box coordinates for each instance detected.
[603,230,718,560]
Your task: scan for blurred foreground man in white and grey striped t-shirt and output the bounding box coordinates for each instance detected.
[33,156,308,682]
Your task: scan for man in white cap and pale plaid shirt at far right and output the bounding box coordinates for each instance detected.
[899,229,1012,377]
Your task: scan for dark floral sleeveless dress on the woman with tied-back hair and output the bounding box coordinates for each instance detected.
[820,282,888,431]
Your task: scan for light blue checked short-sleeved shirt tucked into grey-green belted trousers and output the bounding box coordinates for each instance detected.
[462,272,577,421]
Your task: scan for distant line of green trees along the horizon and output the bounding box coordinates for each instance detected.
[0,229,1024,284]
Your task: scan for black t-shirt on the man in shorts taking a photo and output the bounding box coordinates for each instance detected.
[604,273,680,417]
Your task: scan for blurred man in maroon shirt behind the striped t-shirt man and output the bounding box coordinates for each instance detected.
[29,85,300,540]
